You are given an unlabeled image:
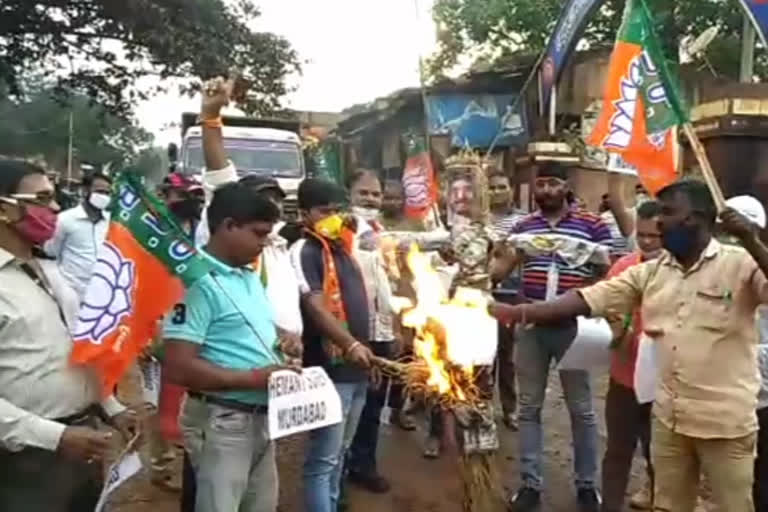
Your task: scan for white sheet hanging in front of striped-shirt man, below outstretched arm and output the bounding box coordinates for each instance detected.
[557,316,613,371]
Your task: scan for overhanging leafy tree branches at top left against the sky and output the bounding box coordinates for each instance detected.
[0,0,299,115]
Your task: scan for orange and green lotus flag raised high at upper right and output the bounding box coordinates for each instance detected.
[587,0,687,194]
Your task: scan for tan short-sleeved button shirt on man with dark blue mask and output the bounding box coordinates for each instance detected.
[579,239,768,439]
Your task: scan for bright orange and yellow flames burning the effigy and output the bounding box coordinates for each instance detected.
[402,244,496,402]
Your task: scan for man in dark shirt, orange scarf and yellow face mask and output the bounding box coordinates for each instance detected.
[291,179,373,512]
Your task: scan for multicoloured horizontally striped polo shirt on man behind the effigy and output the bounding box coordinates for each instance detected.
[512,208,613,300]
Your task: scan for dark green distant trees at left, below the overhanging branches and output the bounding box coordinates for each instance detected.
[0,85,153,171]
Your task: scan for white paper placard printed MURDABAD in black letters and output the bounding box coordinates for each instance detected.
[268,366,341,439]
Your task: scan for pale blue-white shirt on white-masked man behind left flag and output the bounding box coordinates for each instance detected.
[43,204,109,298]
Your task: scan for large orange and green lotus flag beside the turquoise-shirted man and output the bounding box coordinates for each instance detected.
[71,172,210,395]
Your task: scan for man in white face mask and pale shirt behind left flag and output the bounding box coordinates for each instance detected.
[44,173,112,297]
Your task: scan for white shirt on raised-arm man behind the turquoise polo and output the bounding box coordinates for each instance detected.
[195,163,304,334]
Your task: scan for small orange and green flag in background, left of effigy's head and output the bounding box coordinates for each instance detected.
[403,134,437,220]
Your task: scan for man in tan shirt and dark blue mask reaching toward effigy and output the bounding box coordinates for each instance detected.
[490,180,768,512]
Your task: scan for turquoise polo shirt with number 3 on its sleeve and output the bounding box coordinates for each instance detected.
[163,251,282,405]
